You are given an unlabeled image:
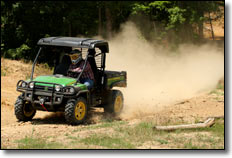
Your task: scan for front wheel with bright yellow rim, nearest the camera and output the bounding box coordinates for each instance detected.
[65,97,88,125]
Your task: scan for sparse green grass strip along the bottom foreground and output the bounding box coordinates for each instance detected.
[12,119,224,149]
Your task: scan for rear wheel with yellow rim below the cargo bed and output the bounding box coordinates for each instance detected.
[104,90,124,116]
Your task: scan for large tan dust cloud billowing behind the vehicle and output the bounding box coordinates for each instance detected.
[106,22,224,118]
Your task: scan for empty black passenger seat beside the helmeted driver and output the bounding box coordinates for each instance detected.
[54,55,71,76]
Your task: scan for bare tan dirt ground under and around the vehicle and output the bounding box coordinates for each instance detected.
[1,59,224,148]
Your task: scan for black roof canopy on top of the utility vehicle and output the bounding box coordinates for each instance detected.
[37,37,109,53]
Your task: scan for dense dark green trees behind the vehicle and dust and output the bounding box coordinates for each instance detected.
[1,1,224,59]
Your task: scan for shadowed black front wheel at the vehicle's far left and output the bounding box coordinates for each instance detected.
[15,96,36,121]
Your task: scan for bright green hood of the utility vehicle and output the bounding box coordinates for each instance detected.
[33,76,76,86]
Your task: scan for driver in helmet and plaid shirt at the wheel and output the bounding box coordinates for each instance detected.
[67,49,95,89]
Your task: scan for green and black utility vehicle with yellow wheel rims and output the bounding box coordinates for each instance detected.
[15,37,127,125]
